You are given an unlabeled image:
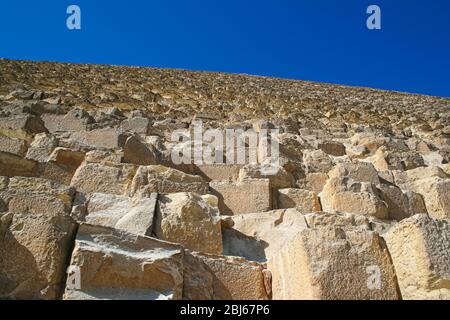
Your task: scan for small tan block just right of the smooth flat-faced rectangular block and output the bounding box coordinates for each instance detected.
[278,188,322,213]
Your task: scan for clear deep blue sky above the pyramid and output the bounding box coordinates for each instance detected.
[0,0,450,97]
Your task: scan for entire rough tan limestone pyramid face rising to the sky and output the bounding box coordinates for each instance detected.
[0,59,450,299]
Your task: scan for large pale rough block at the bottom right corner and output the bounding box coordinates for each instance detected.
[384,215,450,300]
